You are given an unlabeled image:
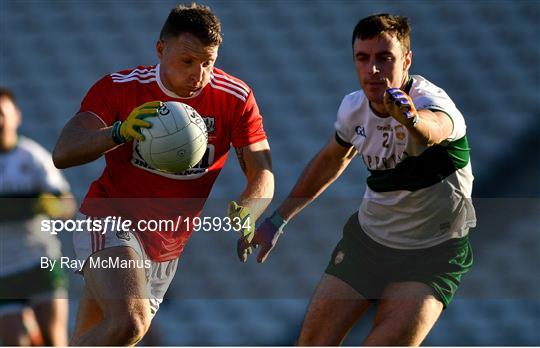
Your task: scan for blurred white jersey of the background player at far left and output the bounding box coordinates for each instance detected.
[0,136,69,276]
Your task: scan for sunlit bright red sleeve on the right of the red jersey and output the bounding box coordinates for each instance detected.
[231,91,266,148]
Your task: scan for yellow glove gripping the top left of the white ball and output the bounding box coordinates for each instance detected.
[112,101,161,144]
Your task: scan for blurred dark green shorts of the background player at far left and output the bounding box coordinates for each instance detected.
[0,264,67,311]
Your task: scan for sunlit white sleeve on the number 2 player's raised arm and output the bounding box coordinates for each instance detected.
[412,83,466,141]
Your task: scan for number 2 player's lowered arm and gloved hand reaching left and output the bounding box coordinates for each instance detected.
[251,136,356,262]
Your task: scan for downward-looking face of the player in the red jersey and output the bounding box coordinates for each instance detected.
[156,34,219,98]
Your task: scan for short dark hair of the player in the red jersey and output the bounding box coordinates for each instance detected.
[159,3,223,46]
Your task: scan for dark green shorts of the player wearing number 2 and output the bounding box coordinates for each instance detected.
[326,213,473,308]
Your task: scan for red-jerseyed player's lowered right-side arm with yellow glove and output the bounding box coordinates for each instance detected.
[229,140,274,262]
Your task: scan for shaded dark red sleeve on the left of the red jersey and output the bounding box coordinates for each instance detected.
[79,75,119,126]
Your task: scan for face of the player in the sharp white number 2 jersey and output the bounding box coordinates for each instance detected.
[353,32,412,104]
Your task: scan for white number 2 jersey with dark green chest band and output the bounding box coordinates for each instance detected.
[335,75,476,249]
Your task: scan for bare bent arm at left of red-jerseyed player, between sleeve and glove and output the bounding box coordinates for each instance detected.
[53,112,118,169]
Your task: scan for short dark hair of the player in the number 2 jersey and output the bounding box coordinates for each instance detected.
[352,13,411,51]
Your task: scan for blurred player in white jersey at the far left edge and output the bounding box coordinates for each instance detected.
[0,88,75,346]
